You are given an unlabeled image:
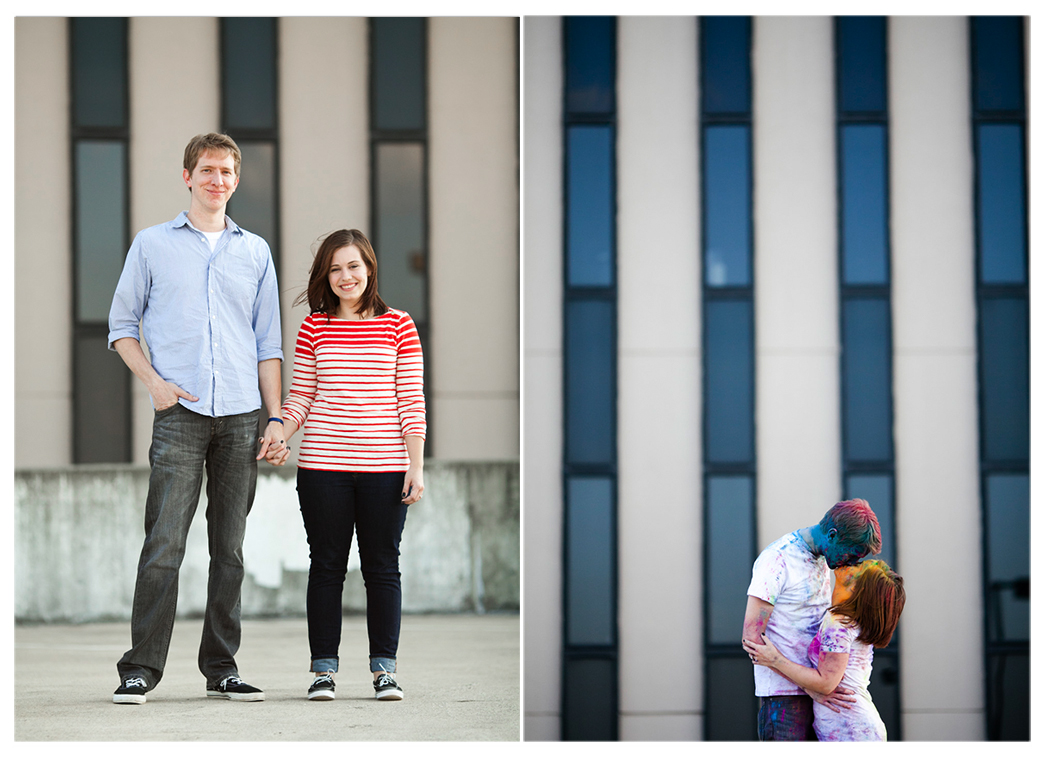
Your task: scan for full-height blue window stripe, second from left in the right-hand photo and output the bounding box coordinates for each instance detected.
[699,16,758,741]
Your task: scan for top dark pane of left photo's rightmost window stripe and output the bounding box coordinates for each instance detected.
[370,18,425,130]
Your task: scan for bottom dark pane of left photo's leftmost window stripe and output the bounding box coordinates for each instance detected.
[73,328,131,464]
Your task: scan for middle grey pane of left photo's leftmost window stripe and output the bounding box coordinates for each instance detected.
[75,140,127,323]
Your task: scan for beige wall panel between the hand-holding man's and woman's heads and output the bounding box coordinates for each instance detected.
[279,17,371,424]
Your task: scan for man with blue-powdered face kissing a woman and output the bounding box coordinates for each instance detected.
[742,499,882,741]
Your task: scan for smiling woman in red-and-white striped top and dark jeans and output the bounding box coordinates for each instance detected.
[266,230,426,699]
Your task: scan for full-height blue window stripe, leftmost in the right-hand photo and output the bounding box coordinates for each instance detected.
[561,16,618,741]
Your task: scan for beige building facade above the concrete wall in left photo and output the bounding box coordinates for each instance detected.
[15,17,519,467]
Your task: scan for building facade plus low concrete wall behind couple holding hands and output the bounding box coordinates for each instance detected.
[14,17,519,620]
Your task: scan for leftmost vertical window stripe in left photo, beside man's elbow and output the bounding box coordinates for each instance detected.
[68,18,132,464]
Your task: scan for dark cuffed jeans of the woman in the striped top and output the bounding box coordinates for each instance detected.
[298,467,407,672]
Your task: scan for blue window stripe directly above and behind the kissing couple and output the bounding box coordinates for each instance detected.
[835,17,903,739]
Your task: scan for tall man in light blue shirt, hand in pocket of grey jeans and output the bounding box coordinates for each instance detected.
[109,133,283,705]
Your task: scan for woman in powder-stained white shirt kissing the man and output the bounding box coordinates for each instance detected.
[744,559,907,741]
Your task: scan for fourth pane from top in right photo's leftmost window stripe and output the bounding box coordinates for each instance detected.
[565,477,617,646]
